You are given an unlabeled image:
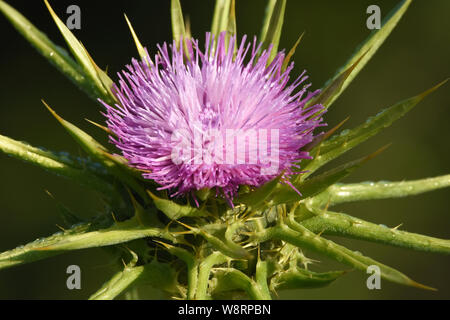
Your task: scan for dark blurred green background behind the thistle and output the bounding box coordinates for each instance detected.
[0,0,450,299]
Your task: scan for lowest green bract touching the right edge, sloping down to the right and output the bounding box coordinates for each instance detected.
[301,211,450,254]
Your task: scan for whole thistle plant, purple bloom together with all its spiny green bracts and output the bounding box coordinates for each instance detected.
[0,0,450,299]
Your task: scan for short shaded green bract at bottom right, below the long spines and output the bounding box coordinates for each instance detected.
[270,268,346,290]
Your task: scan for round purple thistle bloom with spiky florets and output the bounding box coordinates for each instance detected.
[103,32,324,200]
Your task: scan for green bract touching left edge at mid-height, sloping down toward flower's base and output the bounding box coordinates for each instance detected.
[0,135,116,197]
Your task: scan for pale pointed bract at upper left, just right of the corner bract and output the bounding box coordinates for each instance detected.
[44,0,115,103]
